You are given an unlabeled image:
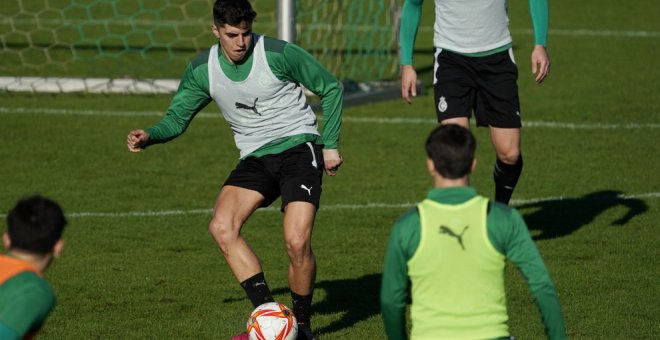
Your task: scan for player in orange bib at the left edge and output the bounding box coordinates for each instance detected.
[0,196,67,340]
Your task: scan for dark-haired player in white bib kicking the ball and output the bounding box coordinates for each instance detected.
[127,0,343,339]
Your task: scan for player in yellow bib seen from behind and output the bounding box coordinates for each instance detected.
[380,124,566,339]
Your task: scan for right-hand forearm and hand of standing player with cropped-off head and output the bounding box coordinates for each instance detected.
[529,0,550,83]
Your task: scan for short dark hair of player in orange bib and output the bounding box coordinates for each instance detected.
[7,195,67,255]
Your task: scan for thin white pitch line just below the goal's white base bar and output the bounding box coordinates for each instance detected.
[0,106,660,130]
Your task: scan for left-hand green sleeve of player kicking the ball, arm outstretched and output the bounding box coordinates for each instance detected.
[146,52,212,146]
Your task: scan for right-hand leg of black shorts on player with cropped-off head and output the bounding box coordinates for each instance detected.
[475,47,521,128]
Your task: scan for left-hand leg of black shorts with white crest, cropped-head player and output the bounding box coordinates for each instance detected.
[433,49,475,122]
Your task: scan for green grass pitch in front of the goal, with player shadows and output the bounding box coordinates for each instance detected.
[0,1,660,339]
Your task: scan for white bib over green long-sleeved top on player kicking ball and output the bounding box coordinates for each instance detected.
[146,34,343,158]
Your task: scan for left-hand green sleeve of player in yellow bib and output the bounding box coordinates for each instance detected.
[380,209,420,340]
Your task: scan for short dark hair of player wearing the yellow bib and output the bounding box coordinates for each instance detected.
[426,124,477,179]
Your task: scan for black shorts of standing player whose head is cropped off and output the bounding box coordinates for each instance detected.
[433,48,521,128]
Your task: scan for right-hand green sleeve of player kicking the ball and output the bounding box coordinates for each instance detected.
[266,41,344,149]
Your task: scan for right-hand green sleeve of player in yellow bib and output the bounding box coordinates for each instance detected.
[488,203,567,340]
